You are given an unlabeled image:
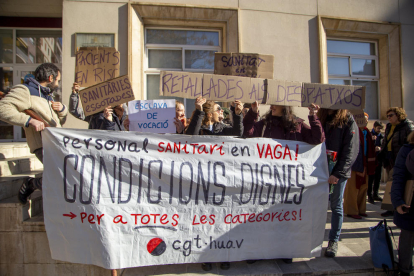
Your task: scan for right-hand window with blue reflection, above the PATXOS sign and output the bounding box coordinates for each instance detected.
[327,39,379,119]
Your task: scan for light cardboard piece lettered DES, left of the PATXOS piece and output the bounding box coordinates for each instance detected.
[266,80,302,106]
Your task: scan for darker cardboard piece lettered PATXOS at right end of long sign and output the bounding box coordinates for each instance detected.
[302,83,365,109]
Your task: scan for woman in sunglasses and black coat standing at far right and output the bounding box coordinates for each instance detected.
[379,107,414,217]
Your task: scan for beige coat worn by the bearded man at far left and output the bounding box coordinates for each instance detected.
[0,84,68,152]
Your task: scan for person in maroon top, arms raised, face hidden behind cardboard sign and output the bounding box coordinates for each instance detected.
[243,101,325,144]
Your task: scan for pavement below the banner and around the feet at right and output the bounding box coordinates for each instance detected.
[118,183,414,276]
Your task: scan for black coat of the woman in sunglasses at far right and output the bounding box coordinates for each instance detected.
[381,119,414,168]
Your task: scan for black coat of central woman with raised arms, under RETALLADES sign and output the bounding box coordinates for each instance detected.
[185,109,243,136]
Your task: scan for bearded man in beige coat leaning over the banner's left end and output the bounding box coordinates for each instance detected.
[0,63,68,204]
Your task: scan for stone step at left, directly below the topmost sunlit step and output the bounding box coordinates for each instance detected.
[0,170,43,200]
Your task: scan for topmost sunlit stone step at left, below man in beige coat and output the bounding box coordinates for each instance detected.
[0,155,43,177]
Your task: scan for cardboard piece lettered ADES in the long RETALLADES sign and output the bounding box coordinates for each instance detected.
[203,74,251,102]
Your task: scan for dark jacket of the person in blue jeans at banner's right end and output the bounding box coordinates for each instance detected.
[323,114,359,178]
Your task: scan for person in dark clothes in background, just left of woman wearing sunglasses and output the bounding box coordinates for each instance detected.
[367,121,384,204]
